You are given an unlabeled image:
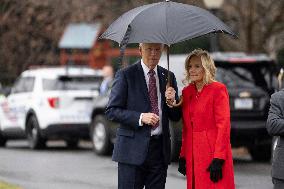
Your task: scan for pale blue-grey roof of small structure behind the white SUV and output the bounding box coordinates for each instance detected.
[59,23,101,49]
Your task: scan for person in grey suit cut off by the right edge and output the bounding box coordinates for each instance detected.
[266,89,284,189]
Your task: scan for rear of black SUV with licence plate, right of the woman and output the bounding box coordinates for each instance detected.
[212,53,277,160]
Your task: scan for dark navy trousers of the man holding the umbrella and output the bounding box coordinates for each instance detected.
[118,137,168,189]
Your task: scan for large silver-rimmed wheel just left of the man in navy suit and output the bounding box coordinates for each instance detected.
[91,115,110,155]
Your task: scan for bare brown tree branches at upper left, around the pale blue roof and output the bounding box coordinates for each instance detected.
[0,0,101,82]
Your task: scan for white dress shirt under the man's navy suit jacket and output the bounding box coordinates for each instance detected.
[139,59,162,136]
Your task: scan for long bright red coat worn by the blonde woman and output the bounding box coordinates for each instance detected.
[180,82,235,189]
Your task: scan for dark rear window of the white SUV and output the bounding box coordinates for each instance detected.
[42,76,103,91]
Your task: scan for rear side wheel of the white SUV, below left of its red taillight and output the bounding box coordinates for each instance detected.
[27,115,46,149]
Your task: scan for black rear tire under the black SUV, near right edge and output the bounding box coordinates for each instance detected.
[249,144,271,162]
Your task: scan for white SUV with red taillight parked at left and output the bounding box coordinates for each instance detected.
[0,66,102,149]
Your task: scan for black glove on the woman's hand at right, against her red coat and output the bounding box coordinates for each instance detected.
[207,158,225,182]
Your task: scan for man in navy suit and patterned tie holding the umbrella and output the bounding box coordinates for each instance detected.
[106,43,181,189]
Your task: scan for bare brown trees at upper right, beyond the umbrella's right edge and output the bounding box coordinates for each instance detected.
[223,0,284,58]
